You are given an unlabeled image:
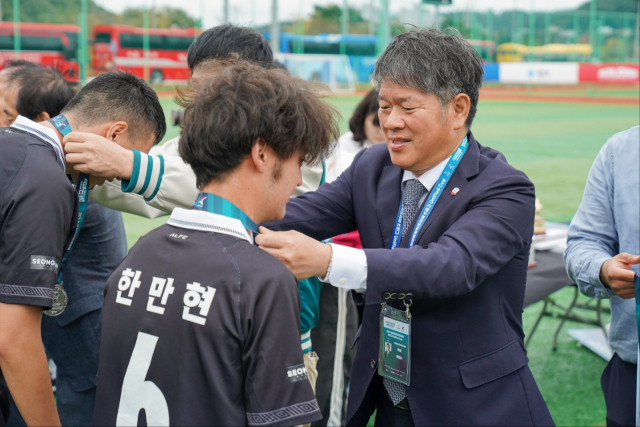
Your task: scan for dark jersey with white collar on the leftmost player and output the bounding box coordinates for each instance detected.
[0,117,77,424]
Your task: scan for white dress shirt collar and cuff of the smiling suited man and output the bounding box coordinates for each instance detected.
[320,157,449,293]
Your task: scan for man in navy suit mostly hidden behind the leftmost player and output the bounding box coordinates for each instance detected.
[4,67,127,426]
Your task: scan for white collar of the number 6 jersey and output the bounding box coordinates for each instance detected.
[167,208,253,244]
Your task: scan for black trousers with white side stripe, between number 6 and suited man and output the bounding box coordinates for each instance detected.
[311,284,358,427]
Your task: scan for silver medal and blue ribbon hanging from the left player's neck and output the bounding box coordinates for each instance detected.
[44,114,89,316]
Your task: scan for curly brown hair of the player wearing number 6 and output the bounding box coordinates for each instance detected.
[179,61,339,188]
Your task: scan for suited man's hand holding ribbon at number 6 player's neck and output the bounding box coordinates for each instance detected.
[256,227,331,280]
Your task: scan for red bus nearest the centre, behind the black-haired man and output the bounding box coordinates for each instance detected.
[91,25,200,83]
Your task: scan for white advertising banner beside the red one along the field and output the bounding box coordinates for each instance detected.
[499,62,579,85]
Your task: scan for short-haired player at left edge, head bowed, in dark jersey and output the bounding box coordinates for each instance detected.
[0,72,166,426]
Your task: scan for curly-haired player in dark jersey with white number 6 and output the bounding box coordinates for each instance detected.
[93,62,337,426]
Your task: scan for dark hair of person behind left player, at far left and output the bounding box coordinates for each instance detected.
[16,67,75,120]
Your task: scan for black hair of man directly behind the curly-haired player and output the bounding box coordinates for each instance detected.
[187,24,273,73]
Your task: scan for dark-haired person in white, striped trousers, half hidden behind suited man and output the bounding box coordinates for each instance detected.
[311,89,384,426]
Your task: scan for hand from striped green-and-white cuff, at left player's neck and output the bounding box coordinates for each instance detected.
[63,132,133,179]
